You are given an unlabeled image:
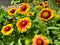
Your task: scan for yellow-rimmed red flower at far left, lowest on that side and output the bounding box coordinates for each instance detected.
[1,24,14,35]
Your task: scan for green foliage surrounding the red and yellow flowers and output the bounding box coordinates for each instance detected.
[0,0,60,45]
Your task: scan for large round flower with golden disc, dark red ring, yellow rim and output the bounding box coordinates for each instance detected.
[39,8,54,21]
